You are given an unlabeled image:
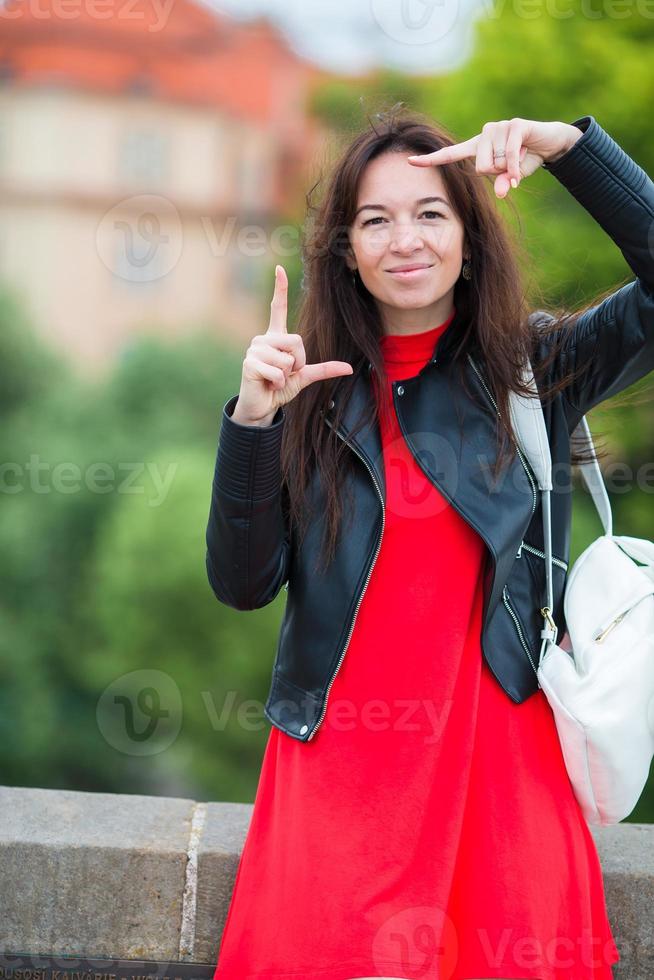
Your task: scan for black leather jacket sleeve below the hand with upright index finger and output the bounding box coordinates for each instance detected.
[206,395,290,610]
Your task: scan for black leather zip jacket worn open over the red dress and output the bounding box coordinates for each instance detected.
[206,116,654,741]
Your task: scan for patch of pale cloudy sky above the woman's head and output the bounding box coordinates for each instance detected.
[207,0,491,75]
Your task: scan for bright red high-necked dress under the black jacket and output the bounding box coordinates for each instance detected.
[214,317,619,980]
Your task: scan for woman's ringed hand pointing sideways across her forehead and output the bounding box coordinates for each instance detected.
[408,117,583,197]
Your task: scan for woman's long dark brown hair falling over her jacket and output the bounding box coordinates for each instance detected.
[281,103,652,562]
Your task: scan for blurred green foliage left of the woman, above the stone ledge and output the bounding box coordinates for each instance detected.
[0,299,283,800]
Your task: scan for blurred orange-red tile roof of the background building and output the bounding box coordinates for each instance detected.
[0,0,336,122]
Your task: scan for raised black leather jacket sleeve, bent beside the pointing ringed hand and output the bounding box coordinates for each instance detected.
[532,116,654,432]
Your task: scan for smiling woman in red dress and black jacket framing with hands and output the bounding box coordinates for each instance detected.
[207,110,654,980]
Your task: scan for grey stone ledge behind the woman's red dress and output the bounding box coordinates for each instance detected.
[0,786,654,980]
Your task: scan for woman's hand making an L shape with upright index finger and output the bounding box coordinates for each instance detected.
[232,265,353,425]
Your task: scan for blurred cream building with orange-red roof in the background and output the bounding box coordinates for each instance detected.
[0,0,324,373]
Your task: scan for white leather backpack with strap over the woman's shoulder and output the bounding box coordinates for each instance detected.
[509,363,654,825]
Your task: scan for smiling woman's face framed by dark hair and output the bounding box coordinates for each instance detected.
[346,152,470,333]
